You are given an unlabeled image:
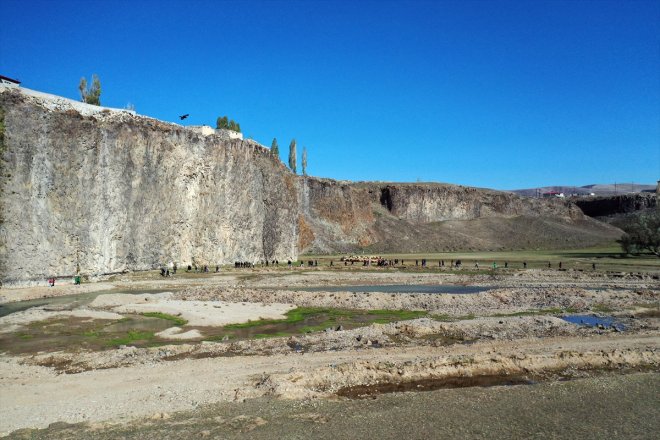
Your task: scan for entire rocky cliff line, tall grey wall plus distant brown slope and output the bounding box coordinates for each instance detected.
[0,89,621,285]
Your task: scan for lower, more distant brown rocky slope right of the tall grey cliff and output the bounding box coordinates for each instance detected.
[299,178,621,253]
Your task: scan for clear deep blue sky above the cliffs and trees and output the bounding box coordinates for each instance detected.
[0,0,660,189]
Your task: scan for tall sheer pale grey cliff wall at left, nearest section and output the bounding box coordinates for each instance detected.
[0,92,299,284]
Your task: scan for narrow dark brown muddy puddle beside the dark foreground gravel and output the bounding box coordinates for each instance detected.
[337,376,536,399]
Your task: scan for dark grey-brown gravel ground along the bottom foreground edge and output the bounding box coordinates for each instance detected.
[11,373,660,440]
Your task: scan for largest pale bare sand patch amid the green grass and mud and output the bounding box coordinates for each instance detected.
[113,295,296,327]
